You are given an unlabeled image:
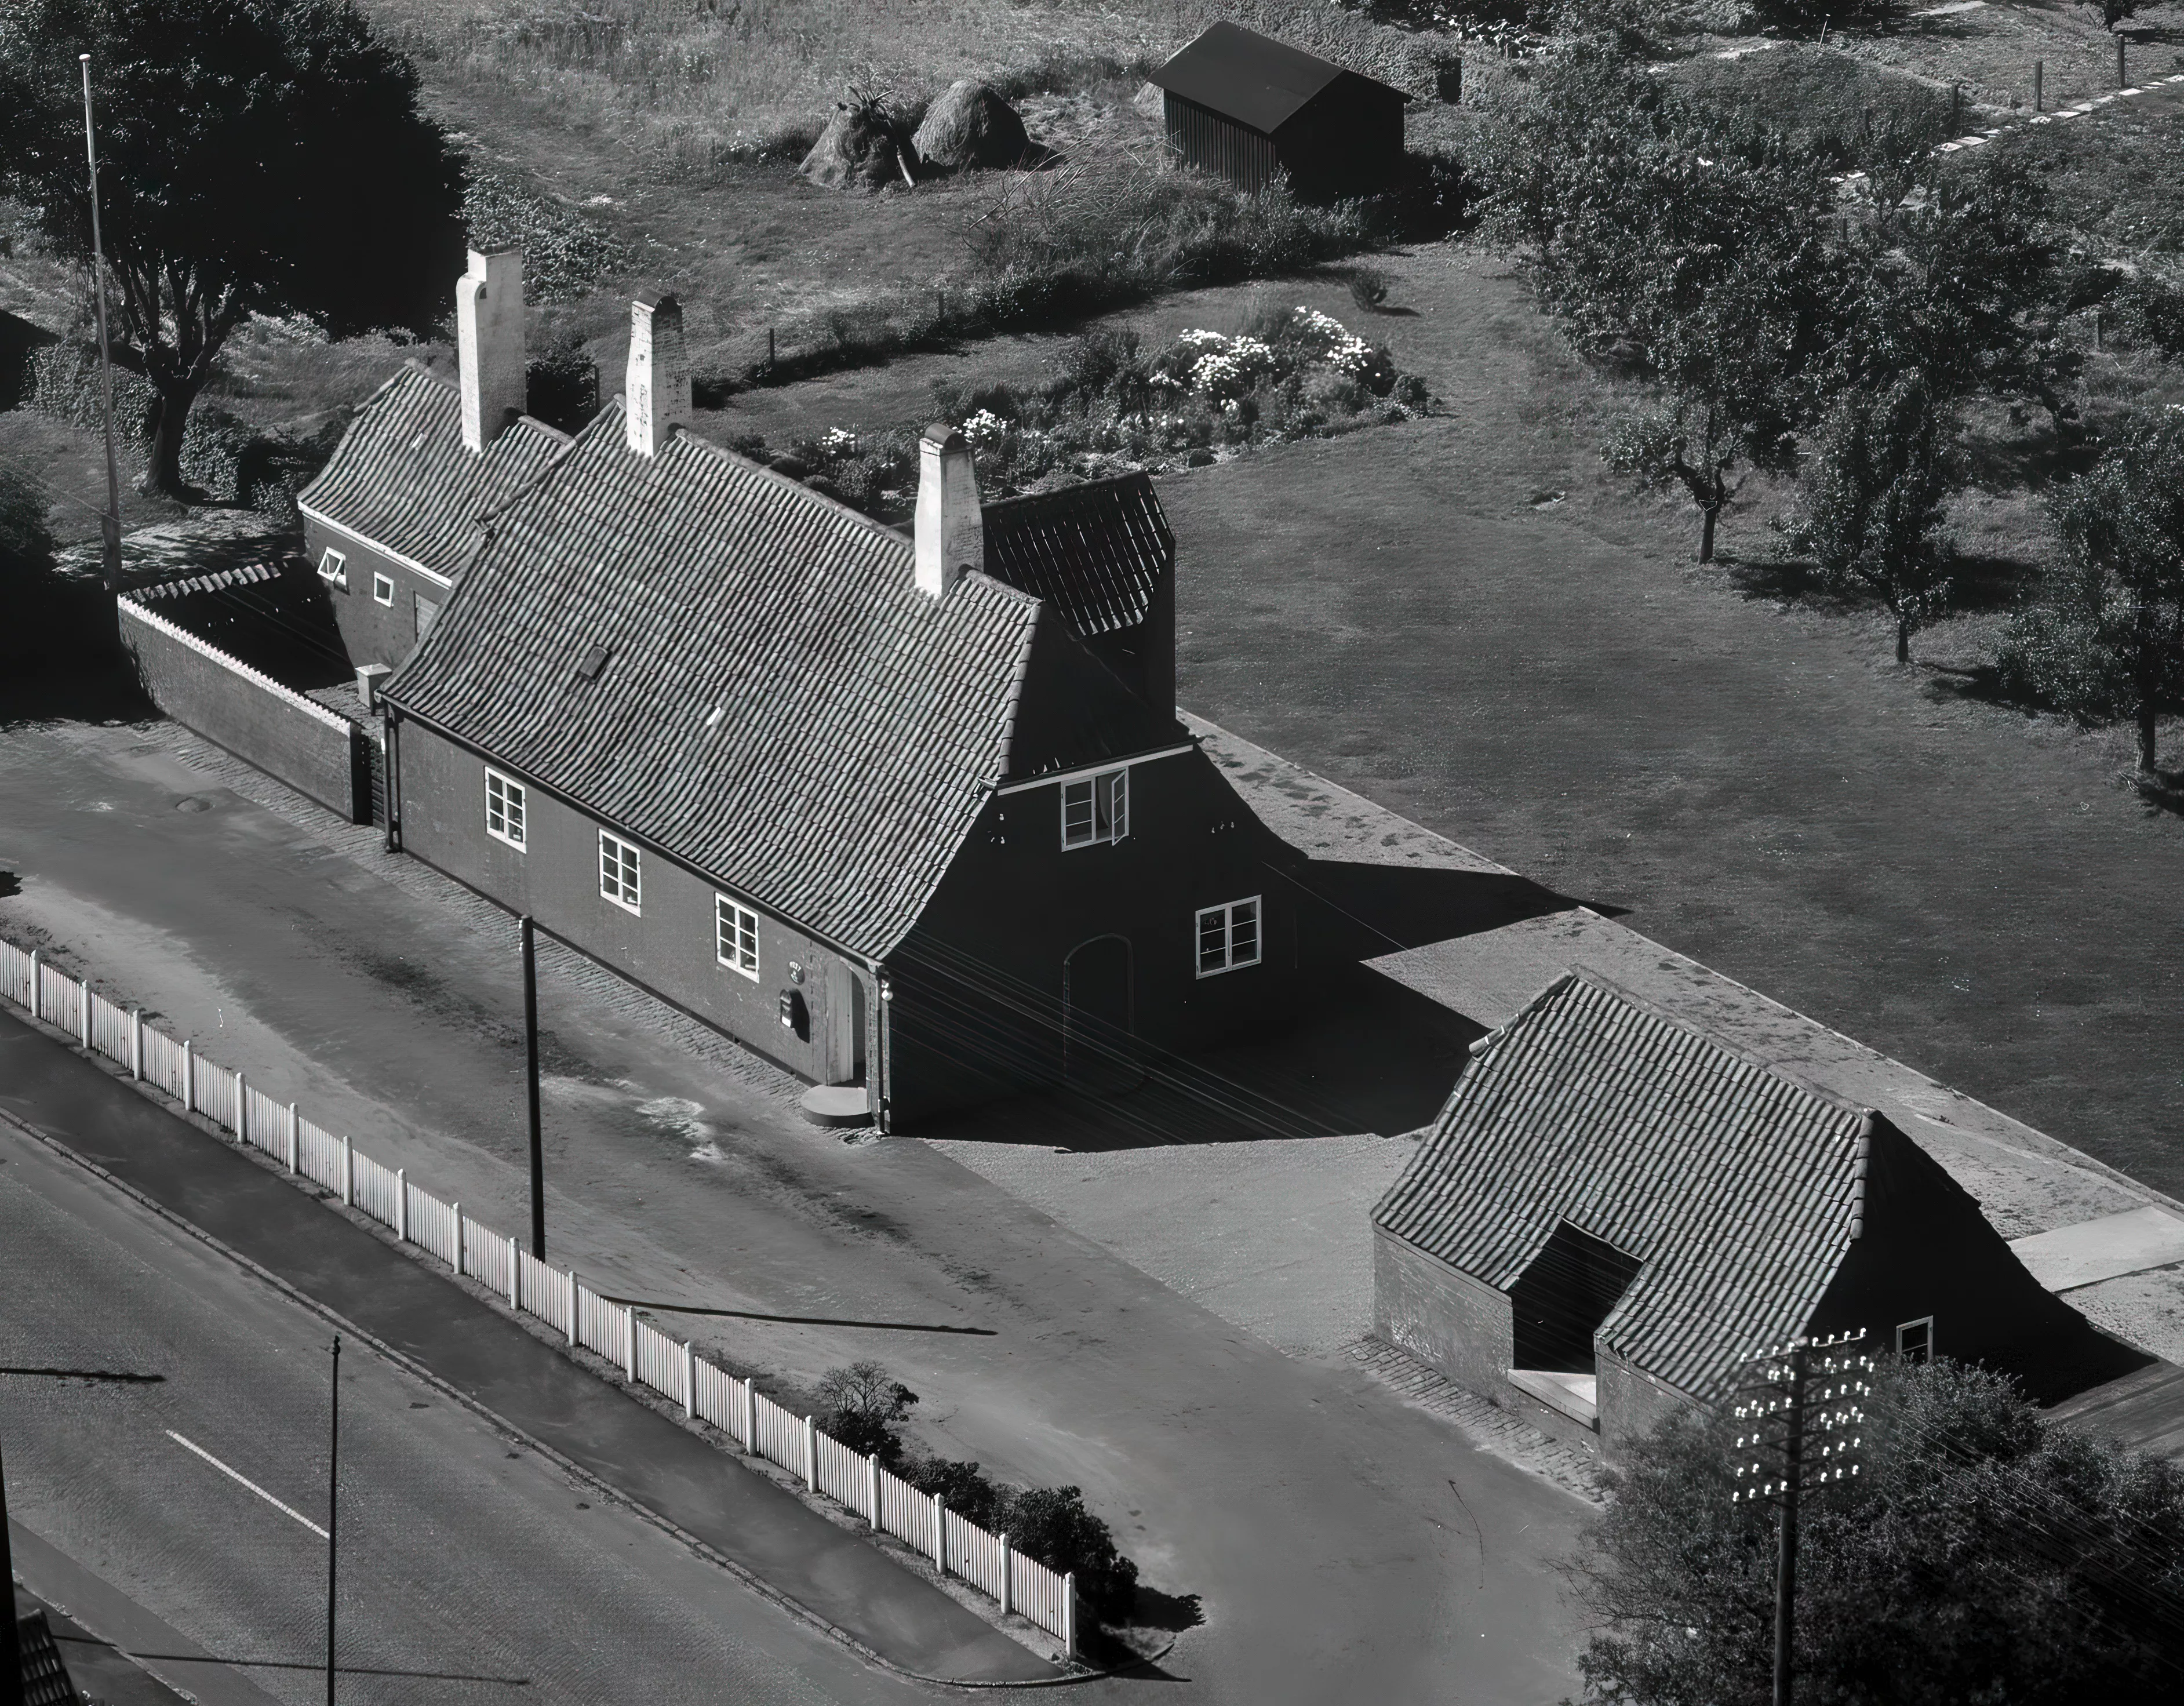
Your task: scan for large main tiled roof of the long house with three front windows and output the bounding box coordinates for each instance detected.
[384,402,1053,955]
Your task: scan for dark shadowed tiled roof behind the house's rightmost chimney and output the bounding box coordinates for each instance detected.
[985,474,1175,640]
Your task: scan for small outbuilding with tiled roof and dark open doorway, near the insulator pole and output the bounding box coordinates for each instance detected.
[1371,972,2119,1453]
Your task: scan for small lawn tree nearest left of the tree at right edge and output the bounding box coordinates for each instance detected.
[1789,369,1959,664]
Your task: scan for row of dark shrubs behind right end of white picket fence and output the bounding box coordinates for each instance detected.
[819,1361,1138,1623]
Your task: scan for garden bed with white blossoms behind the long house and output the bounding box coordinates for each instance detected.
[736,306,1430,522]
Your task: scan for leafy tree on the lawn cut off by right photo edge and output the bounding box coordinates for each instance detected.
[2000,404,2184,771]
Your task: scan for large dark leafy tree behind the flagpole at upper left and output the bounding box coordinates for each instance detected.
[0,0,461,496]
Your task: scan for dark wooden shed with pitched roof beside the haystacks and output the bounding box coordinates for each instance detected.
[1153,24,1408,201]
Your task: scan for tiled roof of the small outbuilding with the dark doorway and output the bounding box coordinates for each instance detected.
[1374,972,1869,1400]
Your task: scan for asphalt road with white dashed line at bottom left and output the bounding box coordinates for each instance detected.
[0,1127,937,1706]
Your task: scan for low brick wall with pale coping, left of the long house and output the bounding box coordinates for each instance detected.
[120,598,372,824]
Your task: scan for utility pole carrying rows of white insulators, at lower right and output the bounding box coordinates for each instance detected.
[1730,1333,1874,1706]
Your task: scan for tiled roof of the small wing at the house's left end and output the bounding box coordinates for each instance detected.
[297,363,568,579]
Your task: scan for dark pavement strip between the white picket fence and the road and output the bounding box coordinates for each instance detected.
[0,1016,1055,1680]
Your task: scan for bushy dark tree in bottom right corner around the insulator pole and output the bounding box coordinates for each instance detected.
[1573,1359,2184,1706]
